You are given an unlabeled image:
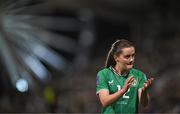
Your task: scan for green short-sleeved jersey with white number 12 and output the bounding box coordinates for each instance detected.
[96,67,147,114]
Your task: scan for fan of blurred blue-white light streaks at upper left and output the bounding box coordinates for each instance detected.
[0,0,81,92]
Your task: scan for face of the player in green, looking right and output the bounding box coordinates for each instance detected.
[115,47,135,70]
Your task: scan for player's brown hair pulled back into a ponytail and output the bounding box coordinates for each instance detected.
[105,39,134,68]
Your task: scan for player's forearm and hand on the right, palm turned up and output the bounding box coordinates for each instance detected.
[138,78,153,107]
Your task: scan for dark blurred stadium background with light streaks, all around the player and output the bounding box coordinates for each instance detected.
[0,0,180,113]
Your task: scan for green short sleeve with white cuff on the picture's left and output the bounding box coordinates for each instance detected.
[96,72,109,94]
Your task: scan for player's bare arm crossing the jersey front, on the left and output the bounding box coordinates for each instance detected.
[99,77,134,107]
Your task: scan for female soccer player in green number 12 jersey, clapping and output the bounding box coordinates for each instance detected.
[96,39,153,114]
